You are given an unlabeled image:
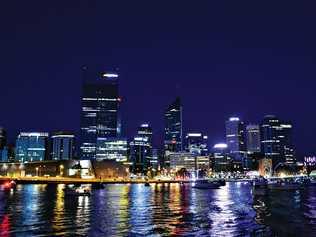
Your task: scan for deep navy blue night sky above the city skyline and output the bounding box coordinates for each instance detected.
[0,0,316,155]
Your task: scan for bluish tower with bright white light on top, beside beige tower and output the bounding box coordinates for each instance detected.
[226,117,246,161]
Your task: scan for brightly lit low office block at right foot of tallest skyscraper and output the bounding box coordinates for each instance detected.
[96,137,128,162]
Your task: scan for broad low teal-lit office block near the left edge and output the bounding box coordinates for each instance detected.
[15,132,49,162]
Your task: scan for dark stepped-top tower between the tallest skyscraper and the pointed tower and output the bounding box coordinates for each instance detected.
[130,124,153,173]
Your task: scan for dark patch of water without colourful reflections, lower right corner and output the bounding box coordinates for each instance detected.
[254,187,316,236]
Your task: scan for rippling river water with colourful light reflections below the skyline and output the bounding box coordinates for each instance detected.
[0,183,316,237]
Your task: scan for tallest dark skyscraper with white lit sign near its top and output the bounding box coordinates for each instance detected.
[80,70,121,159]
